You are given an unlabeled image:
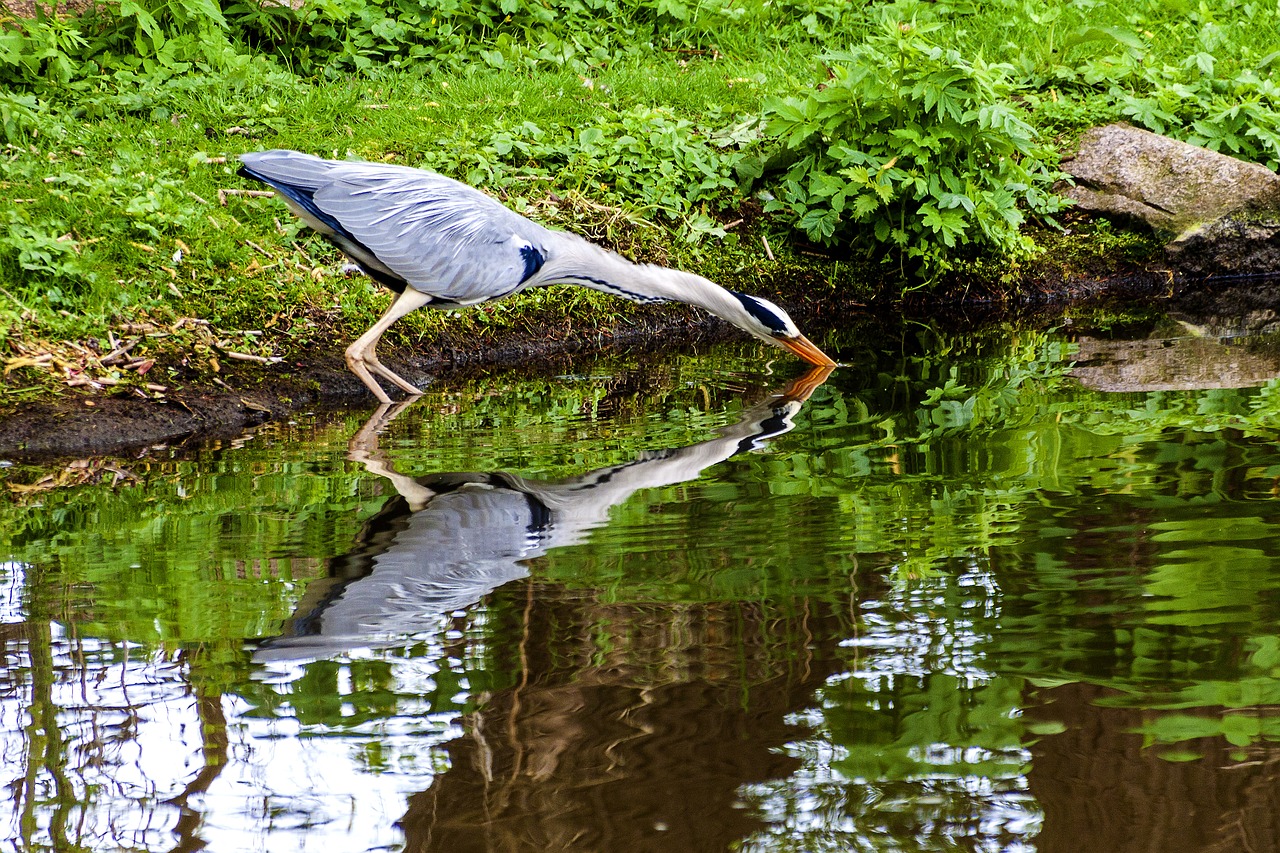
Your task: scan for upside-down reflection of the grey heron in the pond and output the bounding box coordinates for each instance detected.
[256,369,831,660]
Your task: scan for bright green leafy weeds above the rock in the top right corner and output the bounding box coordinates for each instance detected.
[947,0,1280,169]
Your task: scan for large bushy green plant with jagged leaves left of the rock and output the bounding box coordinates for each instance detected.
[764,15,1065,279]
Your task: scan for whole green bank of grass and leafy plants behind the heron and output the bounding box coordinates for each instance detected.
[0,0,1280,402]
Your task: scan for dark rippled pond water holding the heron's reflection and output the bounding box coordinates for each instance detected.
[0,302,1280,853]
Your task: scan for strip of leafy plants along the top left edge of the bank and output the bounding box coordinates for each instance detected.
[0,0,814,86]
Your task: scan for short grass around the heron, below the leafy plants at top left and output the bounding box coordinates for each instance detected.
[0,58,855,391]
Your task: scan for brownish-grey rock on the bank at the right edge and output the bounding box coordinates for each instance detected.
[1062,124,1280,275]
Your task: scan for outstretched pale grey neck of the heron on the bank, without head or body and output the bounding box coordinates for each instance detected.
[543,238,737,316]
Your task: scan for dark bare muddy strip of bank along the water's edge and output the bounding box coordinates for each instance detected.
[0,263,1225,460]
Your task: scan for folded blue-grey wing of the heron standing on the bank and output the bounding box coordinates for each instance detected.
[312,163,550,305]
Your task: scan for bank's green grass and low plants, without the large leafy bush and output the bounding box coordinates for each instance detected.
[0,0,1280,387]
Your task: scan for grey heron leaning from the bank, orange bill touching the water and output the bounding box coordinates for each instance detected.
[239,150,836,403]
